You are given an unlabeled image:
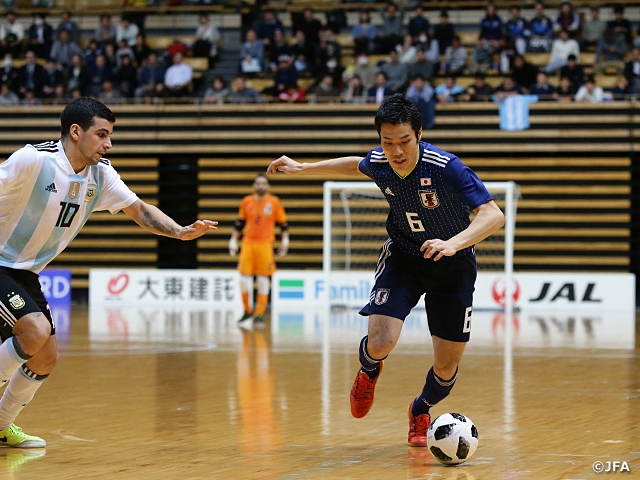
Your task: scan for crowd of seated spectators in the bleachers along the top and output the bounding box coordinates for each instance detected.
[0,1,640,109]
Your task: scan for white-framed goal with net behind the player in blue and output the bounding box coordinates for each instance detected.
[323,182,520,309]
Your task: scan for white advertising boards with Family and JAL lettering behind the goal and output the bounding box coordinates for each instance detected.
[272,270,635,312]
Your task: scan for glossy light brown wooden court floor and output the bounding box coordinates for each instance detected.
[5,307,640,480]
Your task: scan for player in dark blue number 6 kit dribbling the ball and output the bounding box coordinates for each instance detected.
[267,94,504,446]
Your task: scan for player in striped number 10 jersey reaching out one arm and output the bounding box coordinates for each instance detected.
[0,97,217,448]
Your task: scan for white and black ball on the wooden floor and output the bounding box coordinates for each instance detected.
[427,413,478,465]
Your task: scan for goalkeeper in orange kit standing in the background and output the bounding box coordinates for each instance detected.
[229,175,289,328]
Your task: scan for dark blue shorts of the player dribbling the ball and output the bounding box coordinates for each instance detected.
[360,240,477,342]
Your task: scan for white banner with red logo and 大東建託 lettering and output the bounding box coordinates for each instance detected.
[89,269,242,307]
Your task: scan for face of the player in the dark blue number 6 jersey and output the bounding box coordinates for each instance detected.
[380,123,422,177]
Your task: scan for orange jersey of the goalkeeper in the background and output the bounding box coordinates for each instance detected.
[238,193,287,243]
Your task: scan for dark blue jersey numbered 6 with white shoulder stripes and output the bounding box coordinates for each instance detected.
[358,142,493,256]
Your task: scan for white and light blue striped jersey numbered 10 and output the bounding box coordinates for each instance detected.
[0,142,138,273]
